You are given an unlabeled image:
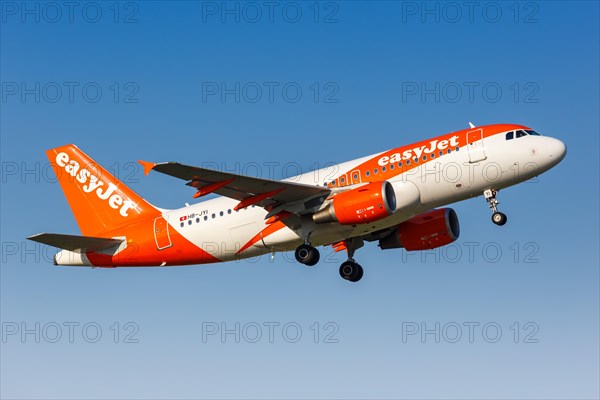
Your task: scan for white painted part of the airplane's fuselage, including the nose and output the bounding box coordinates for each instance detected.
[163,132,564,261]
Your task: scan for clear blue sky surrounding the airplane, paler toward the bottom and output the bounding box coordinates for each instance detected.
[0,2,600,399]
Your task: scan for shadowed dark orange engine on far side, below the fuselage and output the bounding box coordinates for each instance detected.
[379,208,460,250]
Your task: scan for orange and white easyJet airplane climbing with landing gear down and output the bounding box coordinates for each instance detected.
[28,123,567,282]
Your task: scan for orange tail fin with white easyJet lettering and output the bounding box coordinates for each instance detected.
[46,144,157,236]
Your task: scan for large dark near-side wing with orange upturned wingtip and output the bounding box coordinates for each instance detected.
[139,161,331,212]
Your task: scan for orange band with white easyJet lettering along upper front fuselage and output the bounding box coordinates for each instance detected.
[327,124,530,187]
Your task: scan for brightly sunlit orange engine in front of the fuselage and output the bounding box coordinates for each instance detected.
[313,181,396,225]
